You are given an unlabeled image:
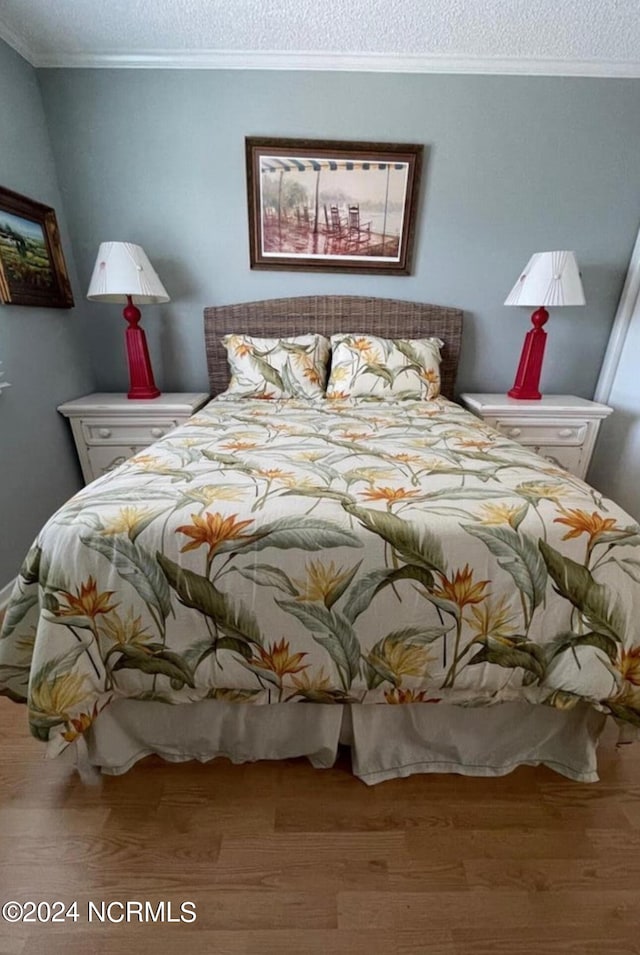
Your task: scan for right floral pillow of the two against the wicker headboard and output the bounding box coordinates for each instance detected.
[327,334,444,399]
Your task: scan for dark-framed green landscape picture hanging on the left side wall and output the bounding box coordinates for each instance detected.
[0,186,73,308]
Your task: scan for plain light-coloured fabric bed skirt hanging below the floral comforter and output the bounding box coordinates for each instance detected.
[76,699,606,785]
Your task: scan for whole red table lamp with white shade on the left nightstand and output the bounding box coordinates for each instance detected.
[87,242,170,398]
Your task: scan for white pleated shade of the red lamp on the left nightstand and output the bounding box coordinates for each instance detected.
[87,242,171,305]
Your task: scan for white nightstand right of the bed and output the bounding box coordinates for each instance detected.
[460,394,613,478]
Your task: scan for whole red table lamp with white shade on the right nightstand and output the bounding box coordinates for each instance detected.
[504,252,585,400]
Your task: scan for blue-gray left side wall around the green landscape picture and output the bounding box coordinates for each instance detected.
[0,41,91,589]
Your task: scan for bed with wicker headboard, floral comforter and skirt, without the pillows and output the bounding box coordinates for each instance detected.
[0,296,640,783]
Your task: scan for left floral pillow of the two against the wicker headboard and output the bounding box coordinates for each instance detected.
[219,335,329,398]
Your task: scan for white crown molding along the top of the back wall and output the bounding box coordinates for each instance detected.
[26,48,640,78]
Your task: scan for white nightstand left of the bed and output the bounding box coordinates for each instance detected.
[58,394,209,483]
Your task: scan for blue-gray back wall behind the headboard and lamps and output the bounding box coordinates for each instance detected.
[39,70,640,397]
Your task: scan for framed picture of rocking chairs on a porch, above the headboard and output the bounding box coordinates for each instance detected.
[245,137,422,275]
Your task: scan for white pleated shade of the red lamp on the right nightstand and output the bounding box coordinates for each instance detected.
[504,252,585,307]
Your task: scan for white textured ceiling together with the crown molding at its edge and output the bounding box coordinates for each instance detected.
[0,0,640,76]
